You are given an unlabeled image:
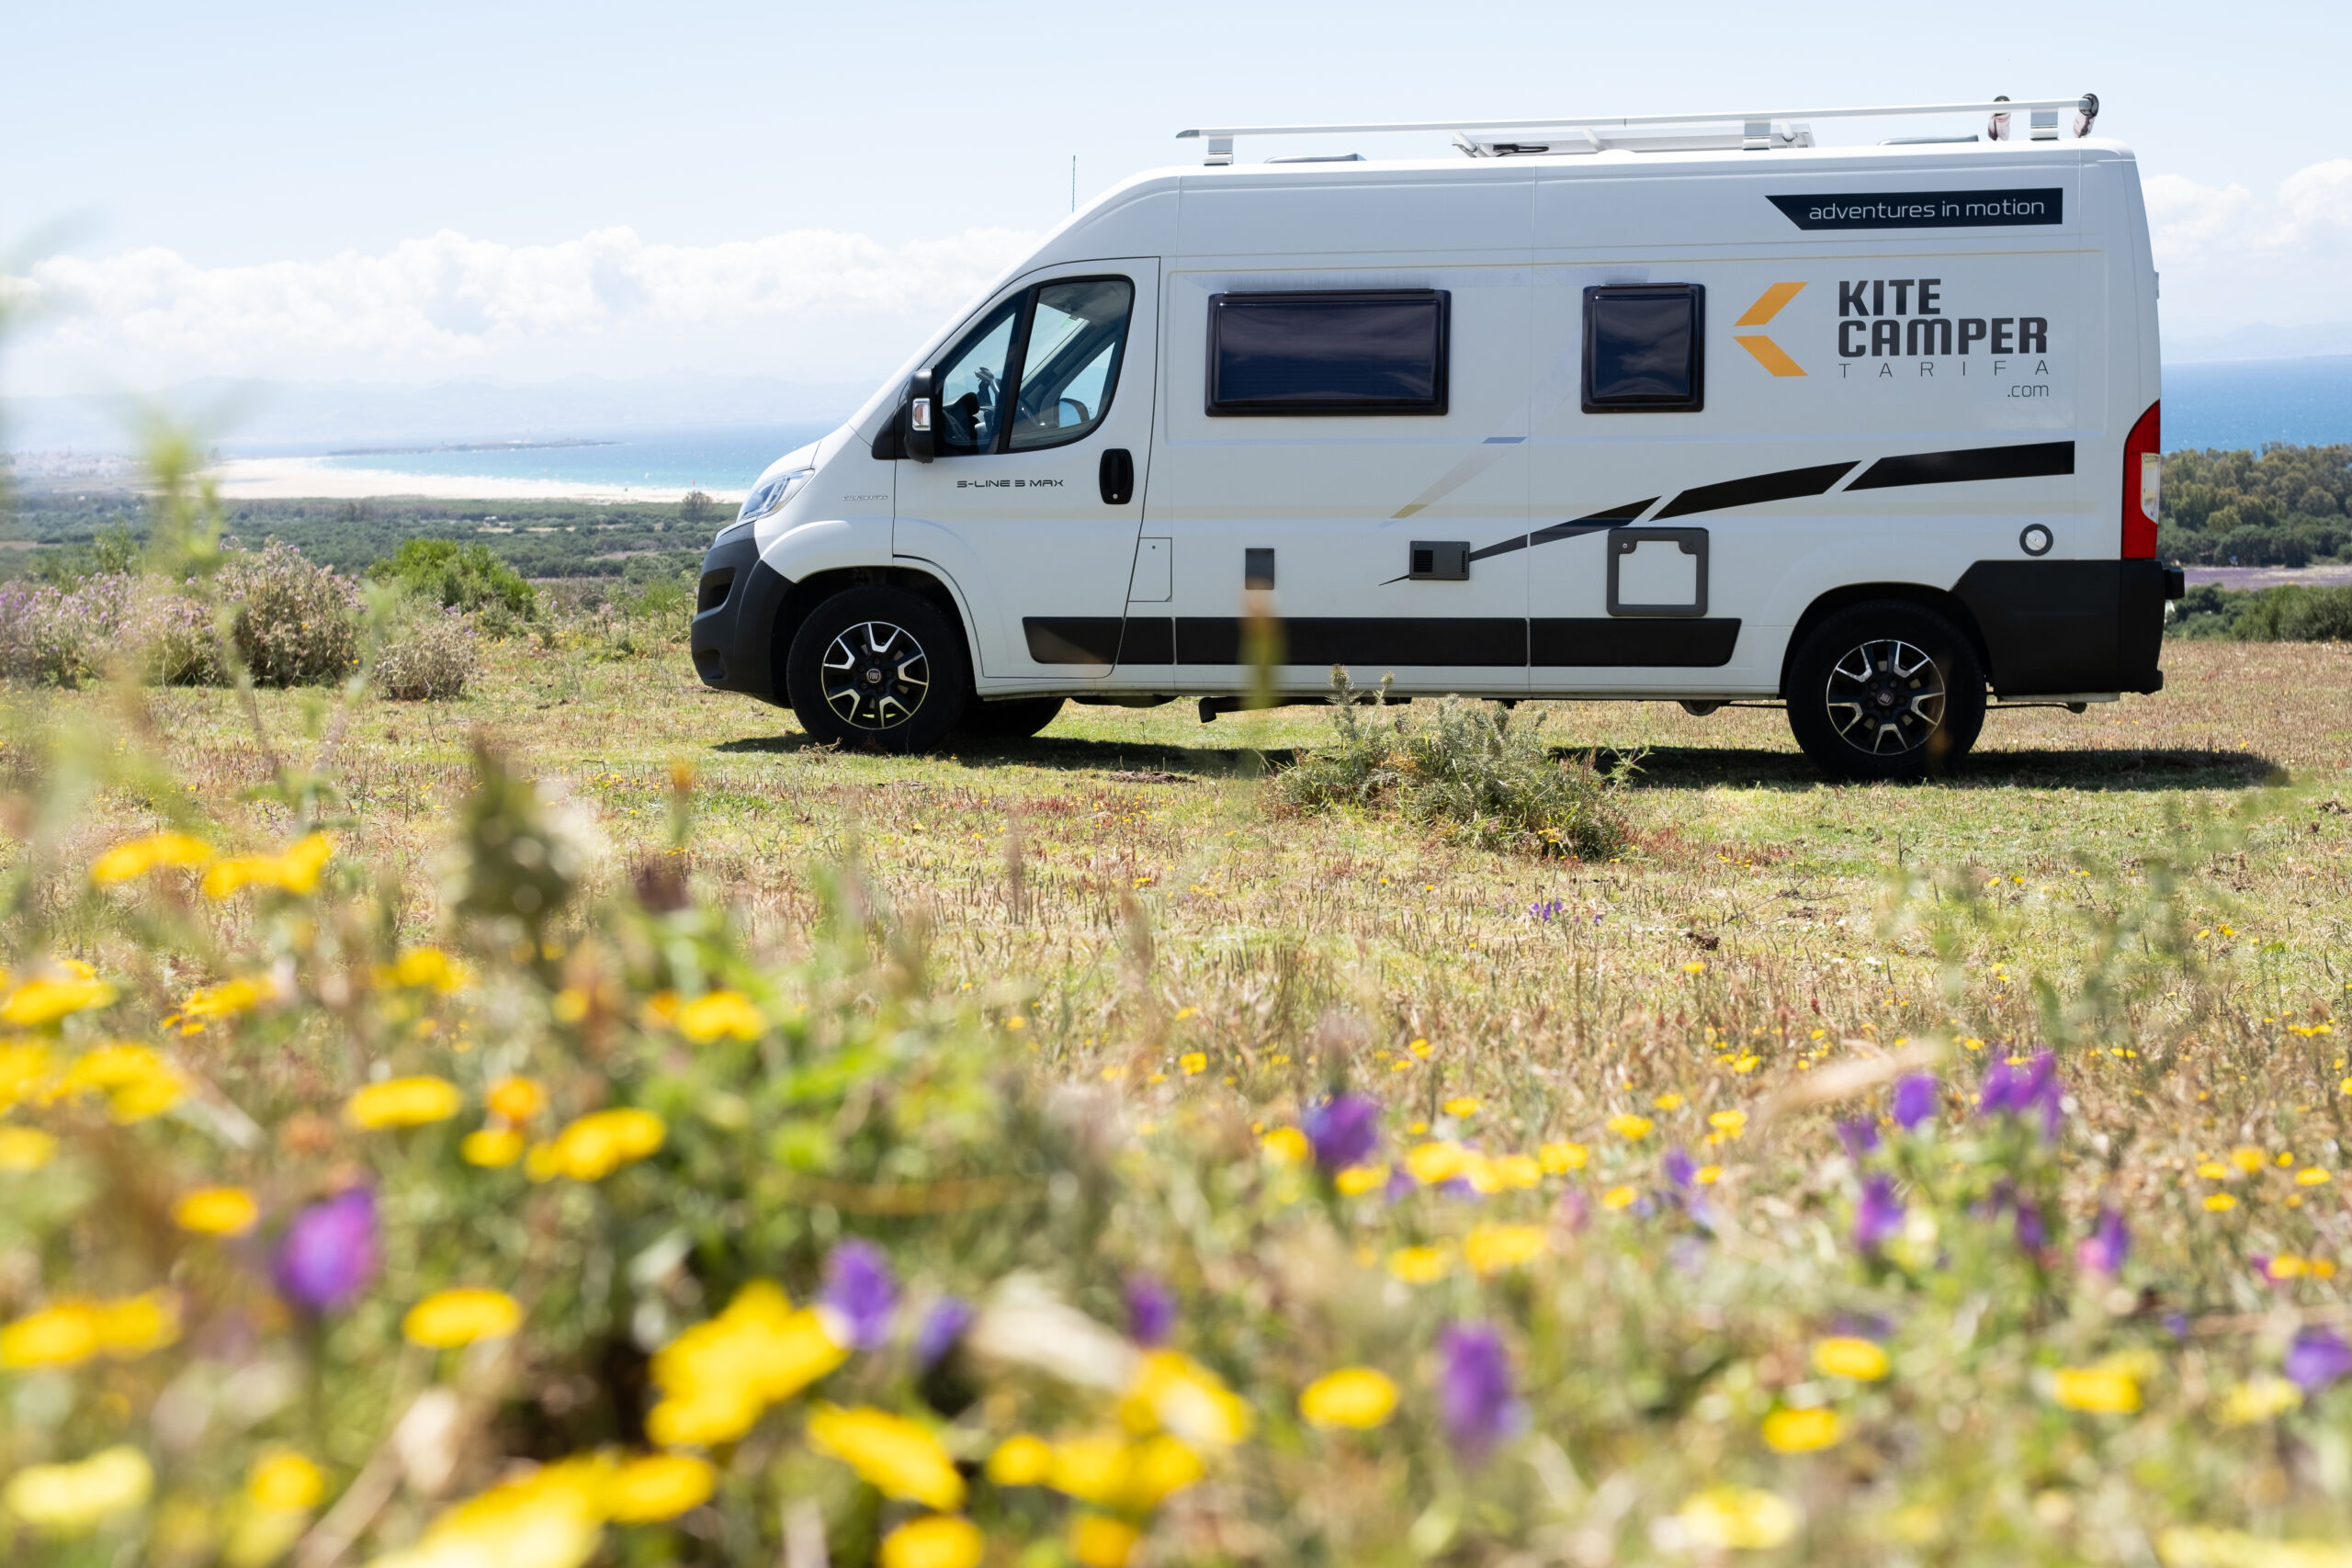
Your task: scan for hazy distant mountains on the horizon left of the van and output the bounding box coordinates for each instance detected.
[0,376,875,456]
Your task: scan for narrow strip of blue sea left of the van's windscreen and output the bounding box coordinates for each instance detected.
[324,423,835,491]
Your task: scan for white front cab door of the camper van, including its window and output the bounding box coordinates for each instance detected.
[891,259,1159,682]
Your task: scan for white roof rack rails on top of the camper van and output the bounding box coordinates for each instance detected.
[1176,92,2098,164]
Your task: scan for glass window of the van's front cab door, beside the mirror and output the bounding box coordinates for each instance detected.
[933,277,1136,456]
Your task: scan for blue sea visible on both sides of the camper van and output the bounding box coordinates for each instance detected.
[270,355,2352,491]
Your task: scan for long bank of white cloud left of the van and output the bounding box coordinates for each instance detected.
[12,228,1037,390]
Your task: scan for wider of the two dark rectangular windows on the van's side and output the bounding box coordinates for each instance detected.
[1209,289,1452,413]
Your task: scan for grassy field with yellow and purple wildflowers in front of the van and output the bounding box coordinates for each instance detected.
[0,620,2352,1568]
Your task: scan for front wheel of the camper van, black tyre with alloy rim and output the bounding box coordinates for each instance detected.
[783,588,971,752]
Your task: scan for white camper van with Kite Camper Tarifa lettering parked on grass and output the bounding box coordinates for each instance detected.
[694,98,2180,778]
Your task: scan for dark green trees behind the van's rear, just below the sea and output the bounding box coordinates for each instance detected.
[2157,446,2352,567]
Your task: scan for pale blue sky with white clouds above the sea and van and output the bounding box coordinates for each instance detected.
[0,0,2352,415]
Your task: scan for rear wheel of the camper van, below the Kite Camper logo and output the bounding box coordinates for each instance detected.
[1785,600,1985,781]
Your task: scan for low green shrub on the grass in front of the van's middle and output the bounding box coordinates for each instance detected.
[1272,668,1630,861]
